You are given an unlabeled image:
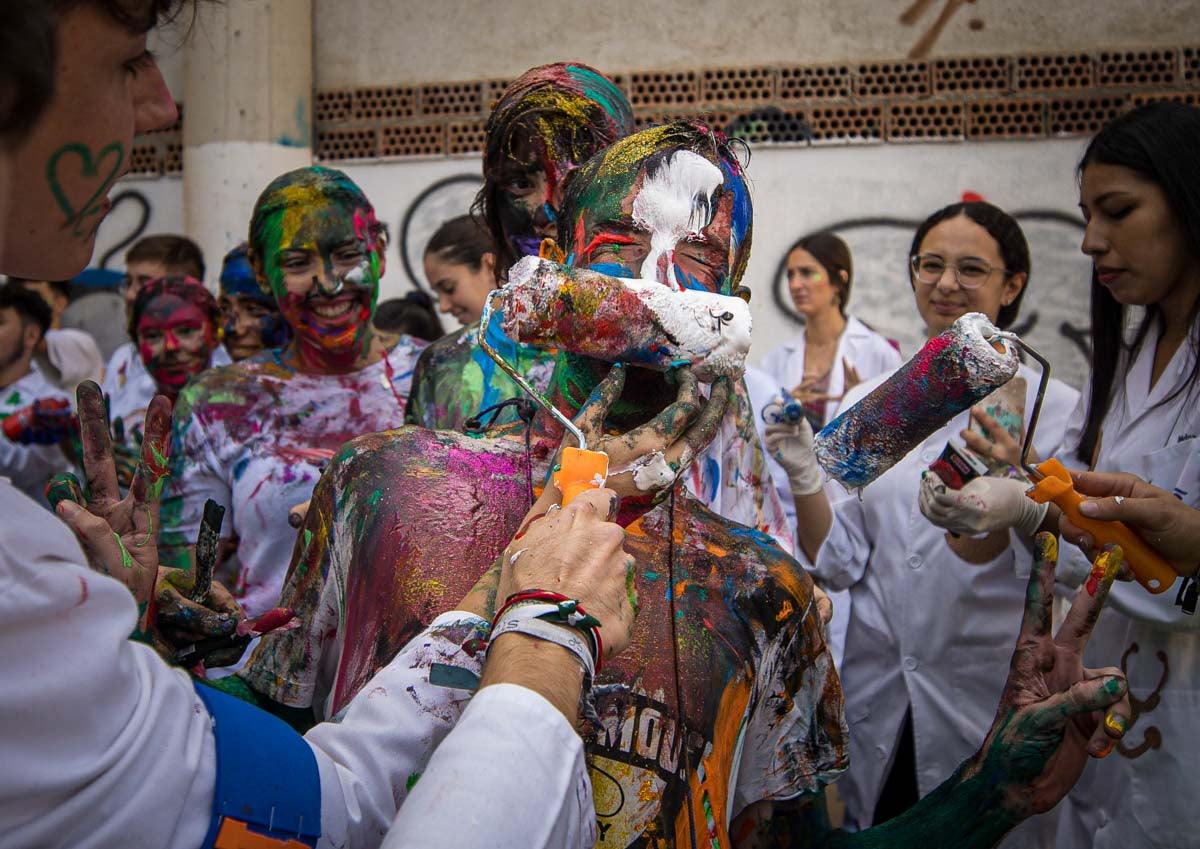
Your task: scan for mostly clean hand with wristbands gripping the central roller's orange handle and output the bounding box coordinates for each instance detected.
[497,489,637,660]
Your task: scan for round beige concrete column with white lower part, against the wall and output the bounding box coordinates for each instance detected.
[181,0,313,288]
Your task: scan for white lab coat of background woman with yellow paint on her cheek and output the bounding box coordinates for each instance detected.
[745,315,904,669]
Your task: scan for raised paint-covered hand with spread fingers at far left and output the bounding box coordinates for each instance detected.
[54,380,170,638]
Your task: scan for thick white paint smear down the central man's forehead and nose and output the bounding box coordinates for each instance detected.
[632,150,725,290]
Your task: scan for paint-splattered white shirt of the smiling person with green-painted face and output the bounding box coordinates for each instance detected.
[160,336,425,616]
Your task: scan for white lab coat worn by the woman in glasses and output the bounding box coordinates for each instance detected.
[815,366,1079,847]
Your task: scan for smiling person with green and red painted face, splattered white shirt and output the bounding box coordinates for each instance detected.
[161,167,424,616]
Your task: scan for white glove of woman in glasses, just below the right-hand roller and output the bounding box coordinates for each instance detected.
[918,470,1050,536]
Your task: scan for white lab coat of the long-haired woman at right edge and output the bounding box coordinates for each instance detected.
[1058,335,1200,849]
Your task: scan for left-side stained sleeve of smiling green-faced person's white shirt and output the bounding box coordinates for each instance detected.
[158,378,235,568]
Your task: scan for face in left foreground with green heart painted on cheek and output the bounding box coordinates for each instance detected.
[0,2,178,279]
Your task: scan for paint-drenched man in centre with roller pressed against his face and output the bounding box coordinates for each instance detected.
[226,122,1122,847]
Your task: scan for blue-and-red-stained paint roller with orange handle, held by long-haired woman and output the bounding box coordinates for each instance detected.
[814,313,1176,594]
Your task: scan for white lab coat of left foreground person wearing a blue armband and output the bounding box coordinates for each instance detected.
[0,478,596,849]
